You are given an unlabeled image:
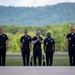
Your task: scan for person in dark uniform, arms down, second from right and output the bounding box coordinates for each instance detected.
[44,32,55,66]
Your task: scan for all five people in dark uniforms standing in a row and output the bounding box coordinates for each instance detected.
[0,27,75,66]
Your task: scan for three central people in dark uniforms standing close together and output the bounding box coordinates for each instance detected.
[20,29,55,66]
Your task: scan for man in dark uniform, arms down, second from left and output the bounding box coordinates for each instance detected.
[20,29,31,66]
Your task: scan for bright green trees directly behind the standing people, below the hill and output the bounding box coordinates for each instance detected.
[1,23,74,52]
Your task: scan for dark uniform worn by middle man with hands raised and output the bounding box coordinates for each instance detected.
[32,36,43,66]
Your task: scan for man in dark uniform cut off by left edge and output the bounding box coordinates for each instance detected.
[0,27,8,66]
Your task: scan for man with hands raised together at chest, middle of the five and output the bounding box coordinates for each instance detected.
[32,30,43,66]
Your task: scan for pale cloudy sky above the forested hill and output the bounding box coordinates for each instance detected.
[0,0,75,7]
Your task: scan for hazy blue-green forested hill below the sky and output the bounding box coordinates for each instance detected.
[0,3,75,26]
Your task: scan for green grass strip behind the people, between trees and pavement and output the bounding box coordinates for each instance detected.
[6,54,69,66]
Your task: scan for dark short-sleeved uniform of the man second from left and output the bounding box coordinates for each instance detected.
[20,35,31,66]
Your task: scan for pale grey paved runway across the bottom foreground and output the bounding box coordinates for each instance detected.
[0,66,75,75]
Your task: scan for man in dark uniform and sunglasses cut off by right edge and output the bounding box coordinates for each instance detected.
[66,27,75,66]
